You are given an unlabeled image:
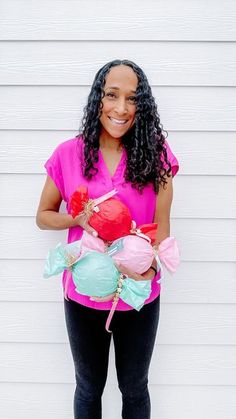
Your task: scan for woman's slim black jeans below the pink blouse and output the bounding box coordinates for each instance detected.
[64,296,160,419]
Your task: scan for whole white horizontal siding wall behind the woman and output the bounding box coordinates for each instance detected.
[0,0,236,419]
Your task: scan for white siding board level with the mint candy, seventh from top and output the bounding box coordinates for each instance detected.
[0,260,236,304]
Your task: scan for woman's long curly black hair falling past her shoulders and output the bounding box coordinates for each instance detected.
[76,59,171,193]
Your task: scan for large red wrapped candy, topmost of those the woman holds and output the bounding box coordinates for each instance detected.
[69,186,132,241]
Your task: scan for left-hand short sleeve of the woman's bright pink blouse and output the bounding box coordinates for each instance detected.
[44,145,65,201]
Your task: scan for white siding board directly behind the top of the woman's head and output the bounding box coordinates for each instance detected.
[0,41,236,86]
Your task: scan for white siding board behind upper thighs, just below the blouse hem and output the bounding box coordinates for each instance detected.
[0,302,236,345]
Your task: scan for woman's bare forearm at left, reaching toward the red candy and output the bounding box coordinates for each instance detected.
[36,210,78,230]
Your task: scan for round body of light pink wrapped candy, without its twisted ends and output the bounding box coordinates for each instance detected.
[108,235,154,274]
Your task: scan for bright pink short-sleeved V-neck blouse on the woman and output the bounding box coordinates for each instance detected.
[45,138,179,310]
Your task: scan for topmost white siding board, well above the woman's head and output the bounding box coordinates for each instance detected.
[0,0,236,41]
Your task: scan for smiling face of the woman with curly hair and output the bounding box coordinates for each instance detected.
[100,65,138,139]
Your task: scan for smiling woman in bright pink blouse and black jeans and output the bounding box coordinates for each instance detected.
[37,60,178,419]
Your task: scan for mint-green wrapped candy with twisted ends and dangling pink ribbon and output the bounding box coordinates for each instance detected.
[44,244,151,331]
